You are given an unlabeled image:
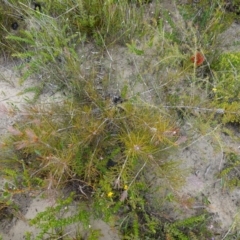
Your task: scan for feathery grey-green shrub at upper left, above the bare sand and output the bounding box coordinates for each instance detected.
[7,13,83,86]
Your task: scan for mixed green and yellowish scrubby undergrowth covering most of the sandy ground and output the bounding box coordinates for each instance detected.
[0,0,240,239]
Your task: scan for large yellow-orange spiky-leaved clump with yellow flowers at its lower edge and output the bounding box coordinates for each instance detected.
[2,90,182,238]
